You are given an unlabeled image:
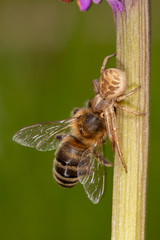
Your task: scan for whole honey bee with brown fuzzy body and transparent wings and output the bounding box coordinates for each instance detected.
[13,107,112,204]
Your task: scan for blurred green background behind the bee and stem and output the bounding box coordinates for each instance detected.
[0,0,160,240]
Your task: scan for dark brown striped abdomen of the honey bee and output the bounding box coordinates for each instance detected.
[53,136,86,188]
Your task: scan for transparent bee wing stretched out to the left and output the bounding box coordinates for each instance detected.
[13,118,75,151]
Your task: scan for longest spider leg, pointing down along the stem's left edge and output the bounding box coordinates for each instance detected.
[110,108,127,173]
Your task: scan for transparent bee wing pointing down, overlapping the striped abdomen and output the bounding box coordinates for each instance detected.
[78,145,105,204]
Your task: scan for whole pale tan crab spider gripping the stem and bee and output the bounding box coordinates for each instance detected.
[90,54,143,172]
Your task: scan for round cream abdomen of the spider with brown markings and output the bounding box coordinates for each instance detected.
[99,68,127,99]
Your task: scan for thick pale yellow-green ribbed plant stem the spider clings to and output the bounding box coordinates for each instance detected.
[112,0,150,240]
